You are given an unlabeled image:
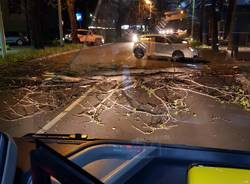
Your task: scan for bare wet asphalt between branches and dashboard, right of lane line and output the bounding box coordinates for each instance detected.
[41,80,250,150]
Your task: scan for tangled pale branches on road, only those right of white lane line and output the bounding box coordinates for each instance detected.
[72,71,249,134]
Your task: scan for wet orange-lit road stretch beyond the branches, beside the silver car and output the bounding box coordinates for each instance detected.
[70,42,188,73]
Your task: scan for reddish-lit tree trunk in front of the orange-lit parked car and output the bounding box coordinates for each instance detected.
[67,0,79,43]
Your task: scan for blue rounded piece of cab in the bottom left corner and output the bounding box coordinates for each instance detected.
[0,132,17,184]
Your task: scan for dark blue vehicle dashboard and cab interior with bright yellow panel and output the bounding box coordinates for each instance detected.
[0,133,250,184]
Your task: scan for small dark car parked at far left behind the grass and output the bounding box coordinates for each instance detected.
[5,32,29,46]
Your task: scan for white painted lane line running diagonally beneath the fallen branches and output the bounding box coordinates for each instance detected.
[37,86,95,134]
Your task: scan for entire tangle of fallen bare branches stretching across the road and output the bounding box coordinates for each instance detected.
[1,71,250,135]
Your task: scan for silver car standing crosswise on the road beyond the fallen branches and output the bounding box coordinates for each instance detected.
[133,34,198,60]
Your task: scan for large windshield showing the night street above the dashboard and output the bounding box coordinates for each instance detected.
[0,0,250,150]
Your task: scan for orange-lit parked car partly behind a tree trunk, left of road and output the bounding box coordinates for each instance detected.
[64,29,105,45]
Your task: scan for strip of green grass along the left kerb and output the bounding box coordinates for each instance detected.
[0,44,83,64]
